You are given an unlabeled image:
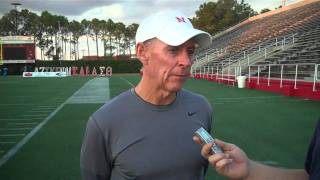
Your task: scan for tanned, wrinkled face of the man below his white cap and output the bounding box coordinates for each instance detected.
[143,39,195,92]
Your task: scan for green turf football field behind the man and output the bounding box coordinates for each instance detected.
[0,75,320,180]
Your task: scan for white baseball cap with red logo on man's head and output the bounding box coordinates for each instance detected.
[136,10,211,47]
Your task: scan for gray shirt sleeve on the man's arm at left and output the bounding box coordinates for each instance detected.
[80,117,111,180]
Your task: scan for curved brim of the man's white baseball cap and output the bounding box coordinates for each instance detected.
[157,28,212,48]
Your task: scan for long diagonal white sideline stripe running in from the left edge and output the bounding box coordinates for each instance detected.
[0,78,110,167]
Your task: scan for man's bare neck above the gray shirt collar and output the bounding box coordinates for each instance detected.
[135,81,176,105]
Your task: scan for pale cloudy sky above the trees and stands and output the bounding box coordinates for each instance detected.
[0,0,297,25]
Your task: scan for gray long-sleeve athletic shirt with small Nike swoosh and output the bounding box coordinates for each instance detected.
[80,89,212,180]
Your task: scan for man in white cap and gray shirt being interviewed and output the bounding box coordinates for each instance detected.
[80,10,212,180]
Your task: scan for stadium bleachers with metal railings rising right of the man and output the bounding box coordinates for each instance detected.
[192,0,320,100]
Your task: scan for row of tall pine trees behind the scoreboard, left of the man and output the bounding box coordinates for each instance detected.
[0,9,138,60]
